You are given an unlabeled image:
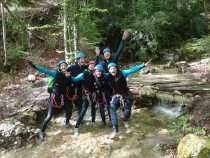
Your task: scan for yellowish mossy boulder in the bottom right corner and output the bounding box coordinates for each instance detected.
[177,134,210,158]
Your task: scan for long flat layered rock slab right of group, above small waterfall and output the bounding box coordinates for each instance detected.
[128,73,210,93]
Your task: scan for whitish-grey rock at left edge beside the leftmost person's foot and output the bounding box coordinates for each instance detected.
[0,118,35,149]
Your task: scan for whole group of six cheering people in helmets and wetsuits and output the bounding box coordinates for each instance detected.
[29,31,150,139]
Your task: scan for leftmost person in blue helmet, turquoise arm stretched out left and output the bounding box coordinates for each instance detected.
[29,60,74,140]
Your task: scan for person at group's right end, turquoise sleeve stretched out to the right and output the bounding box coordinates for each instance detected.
[107,60,151,138]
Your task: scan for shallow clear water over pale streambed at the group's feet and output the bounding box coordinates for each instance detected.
[0,109,176,158]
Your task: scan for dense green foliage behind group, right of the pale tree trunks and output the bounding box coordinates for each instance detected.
[77,0,204,59]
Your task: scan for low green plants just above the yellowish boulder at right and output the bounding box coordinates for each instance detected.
[168,115,206,135]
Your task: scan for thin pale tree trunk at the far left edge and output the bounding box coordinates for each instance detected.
[1,3,7,66]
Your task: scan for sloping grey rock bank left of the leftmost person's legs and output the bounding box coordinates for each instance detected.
[0,79,49,119]
